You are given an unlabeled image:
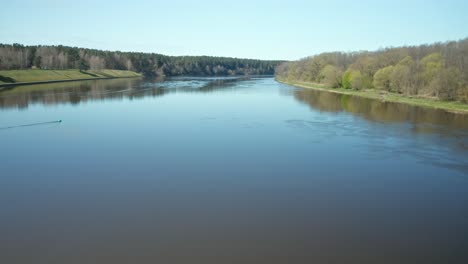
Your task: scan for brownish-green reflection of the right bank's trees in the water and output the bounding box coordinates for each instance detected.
[294,89,468,132]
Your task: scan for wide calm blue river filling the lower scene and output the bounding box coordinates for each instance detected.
[0,78,468,264]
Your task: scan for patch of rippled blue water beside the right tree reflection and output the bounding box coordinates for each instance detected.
[284,118,468,175]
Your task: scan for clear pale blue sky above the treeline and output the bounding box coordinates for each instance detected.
[0,0,468,60]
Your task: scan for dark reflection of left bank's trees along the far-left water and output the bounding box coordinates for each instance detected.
[0,78,252,108]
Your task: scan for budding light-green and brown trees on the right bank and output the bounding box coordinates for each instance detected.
[276,38,468,102]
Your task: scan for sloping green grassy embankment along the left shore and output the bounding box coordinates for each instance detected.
[0,69,141,84]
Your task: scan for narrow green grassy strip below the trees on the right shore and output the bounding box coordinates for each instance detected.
[275,78,468,114]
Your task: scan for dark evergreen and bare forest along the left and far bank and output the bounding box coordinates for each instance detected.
[0,44,281,76]
